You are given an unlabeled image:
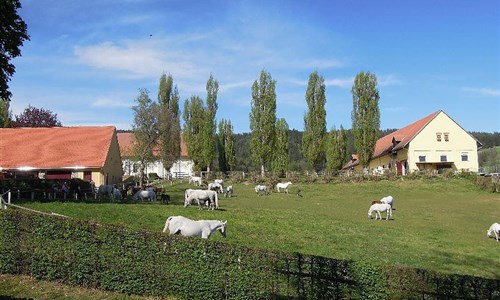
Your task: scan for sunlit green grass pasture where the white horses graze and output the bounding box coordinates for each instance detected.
[17,178,500,279]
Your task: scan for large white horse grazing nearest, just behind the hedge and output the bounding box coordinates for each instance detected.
[163,216,227,239]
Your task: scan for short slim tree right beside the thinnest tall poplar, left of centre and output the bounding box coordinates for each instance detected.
[218,119,236,172]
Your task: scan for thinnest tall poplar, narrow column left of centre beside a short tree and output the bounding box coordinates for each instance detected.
[202,74,219,172]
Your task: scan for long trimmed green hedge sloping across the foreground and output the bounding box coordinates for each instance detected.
[0,209,500,299]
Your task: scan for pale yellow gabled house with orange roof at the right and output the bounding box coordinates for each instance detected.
[344,110,481,175]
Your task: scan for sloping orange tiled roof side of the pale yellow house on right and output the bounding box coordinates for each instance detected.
[372,110,442,159]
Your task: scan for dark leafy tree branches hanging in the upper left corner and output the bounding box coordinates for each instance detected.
[0,0,29,101]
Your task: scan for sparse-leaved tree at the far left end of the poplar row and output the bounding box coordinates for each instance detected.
[132,89,159,188]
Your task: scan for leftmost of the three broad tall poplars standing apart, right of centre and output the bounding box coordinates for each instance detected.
[250,70,276,176]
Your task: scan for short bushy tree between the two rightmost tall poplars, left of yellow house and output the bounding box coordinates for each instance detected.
[326,126,347,171]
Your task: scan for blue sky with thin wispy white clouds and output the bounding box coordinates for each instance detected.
[10,0,500,133]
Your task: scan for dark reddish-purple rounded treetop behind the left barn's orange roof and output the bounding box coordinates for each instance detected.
[12,105,62,127]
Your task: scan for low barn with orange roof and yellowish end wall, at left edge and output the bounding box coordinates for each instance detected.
[0,126,123,186]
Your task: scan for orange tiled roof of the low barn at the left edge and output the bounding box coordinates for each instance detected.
[0,126,115,170]
